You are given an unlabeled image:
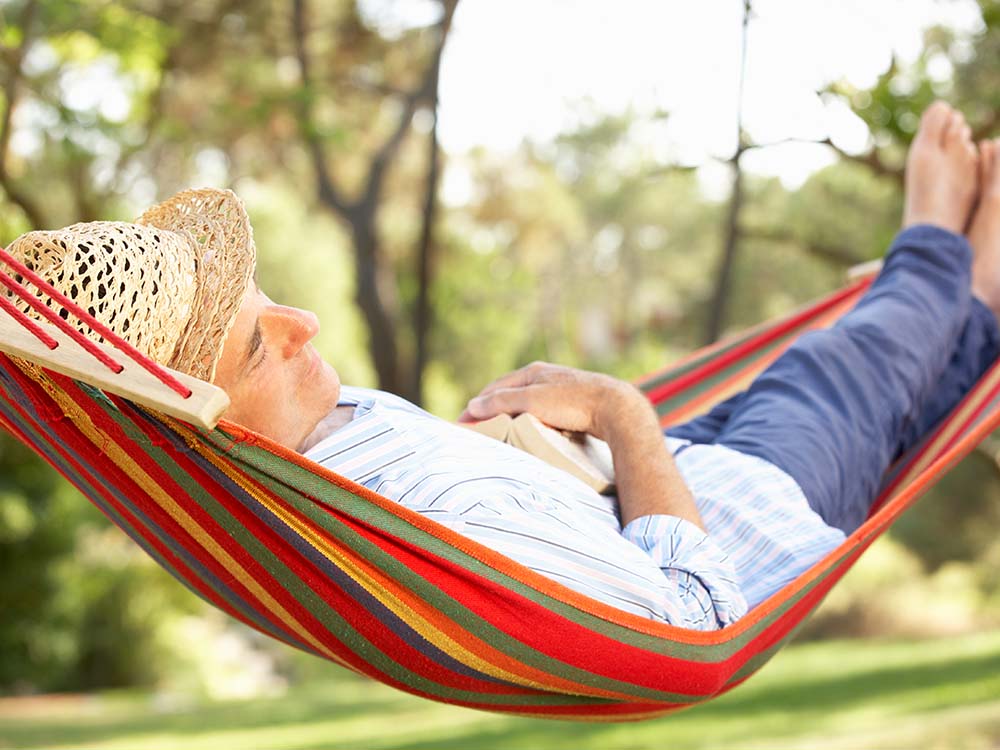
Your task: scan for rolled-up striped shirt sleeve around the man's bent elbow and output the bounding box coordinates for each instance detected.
[622,515,748,629]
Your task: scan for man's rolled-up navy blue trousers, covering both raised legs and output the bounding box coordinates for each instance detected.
[666,226,1000,533]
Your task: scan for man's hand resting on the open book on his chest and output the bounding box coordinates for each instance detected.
[458,362,652,440]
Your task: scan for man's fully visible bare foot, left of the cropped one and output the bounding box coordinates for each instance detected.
[903,102,979,233]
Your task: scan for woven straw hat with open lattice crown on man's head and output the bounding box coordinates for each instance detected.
[7,189,256,381]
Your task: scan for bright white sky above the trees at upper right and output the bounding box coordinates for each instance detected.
[428,0,981,198]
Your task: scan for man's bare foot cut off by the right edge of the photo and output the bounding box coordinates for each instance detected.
[969,141,1000,317]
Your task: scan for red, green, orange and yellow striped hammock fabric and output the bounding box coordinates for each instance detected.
[0,278,1000,721]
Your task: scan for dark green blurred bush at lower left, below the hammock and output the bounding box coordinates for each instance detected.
[0,433,201,693]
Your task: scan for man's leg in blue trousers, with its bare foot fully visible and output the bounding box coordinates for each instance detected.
[670,104,981,531]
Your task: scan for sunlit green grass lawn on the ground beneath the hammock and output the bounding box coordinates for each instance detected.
[0,631,1000,750]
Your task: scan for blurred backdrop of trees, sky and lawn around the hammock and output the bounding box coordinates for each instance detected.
[0,0,1000,748]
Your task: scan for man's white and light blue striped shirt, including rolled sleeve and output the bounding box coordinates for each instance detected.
[306,386,844,630]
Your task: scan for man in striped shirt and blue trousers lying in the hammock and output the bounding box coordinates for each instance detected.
[11,103,1000,629]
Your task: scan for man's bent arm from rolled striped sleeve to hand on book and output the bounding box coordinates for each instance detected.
[460,362,747,629]
